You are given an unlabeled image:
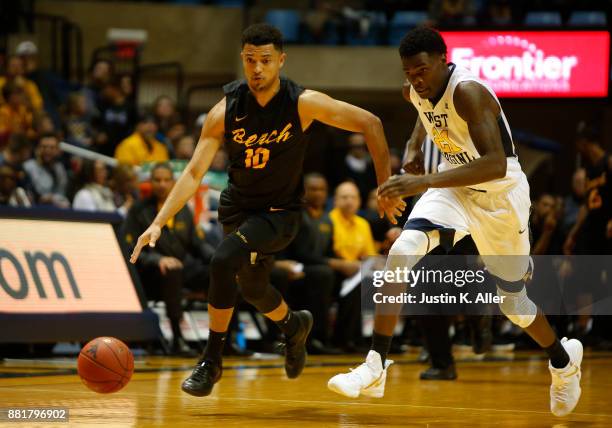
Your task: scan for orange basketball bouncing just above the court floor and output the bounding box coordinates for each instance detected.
[77,337,134,394]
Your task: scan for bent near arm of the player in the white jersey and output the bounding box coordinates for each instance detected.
[379,81,506,197]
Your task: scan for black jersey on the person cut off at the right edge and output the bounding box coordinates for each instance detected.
[584,153,612,250]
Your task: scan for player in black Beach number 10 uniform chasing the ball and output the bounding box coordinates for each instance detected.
[131,24,404,396]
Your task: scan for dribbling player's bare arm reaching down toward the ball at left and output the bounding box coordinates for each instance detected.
[130,98,225,263]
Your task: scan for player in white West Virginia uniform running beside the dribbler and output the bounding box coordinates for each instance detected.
[328,27,583,416]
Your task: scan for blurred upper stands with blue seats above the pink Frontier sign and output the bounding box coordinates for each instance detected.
[268,0,611,45]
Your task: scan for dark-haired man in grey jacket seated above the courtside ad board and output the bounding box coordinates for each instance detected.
[23,134,70,208]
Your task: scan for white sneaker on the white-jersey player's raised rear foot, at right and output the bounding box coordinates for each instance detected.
[548,337,582,416]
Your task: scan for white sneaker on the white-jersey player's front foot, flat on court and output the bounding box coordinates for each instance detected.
[327,350,393,398]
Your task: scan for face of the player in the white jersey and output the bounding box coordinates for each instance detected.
[402,52,448,98]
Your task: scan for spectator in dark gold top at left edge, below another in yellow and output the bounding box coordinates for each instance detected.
[0,82,36,148]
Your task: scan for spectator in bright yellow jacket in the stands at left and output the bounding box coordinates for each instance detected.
[115,115,169,165]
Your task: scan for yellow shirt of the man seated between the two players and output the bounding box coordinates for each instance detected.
[329,208,378,261]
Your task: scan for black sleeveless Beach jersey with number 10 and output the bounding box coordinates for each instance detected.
[220,77,306,222]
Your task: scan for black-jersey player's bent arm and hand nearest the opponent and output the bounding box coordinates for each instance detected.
[298,90,406,224]
